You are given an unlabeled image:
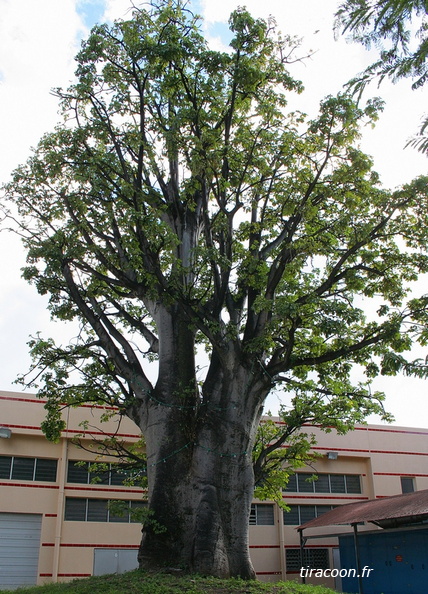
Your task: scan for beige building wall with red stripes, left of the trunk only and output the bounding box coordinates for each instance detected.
[0,391,143,583]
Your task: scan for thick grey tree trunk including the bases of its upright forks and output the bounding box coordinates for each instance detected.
[133,303,269,579]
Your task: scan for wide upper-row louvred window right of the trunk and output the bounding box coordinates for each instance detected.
[283,472,361,493]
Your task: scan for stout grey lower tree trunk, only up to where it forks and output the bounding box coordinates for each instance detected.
[139,358,260,579]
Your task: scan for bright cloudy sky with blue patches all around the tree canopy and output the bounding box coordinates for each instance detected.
[0,0,428,427]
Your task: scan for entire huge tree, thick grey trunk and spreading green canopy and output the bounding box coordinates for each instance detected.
[5,1,428,577]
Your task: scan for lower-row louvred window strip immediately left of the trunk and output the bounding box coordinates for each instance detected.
[64,497,147,524]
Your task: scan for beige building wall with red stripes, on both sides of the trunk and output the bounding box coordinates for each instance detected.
[0,391,428,586]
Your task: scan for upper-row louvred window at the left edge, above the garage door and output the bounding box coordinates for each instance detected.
[0,456,57,483]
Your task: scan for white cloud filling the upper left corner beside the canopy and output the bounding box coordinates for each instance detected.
[0,0,83,181]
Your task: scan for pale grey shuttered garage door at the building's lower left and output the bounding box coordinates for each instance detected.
[0,513,42,590]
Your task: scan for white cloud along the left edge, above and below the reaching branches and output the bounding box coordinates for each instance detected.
[0,0,85,389]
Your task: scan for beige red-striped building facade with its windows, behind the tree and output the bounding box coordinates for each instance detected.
[0,391,428,589]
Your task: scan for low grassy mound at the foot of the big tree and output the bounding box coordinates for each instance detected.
[2,570,333,594]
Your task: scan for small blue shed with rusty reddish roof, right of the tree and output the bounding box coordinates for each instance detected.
[297,490,428,594]
